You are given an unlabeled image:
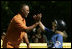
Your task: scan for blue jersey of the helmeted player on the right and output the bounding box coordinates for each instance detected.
[45,28,63,48]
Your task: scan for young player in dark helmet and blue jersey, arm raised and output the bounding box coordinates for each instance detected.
[40,20,67,48]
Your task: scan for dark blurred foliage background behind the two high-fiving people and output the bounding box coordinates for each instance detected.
[1,1,71,42]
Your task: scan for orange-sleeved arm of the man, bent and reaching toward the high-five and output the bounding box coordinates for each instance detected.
[15,19,39,31]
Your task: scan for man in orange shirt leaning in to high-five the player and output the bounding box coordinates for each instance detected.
[3,4,39,48]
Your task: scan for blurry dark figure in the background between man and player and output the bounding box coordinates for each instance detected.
[32,27,47,43]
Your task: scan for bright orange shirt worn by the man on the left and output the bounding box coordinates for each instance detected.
[3,14,27,47]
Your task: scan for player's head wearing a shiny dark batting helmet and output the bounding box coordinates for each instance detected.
[52,20,66,31]
